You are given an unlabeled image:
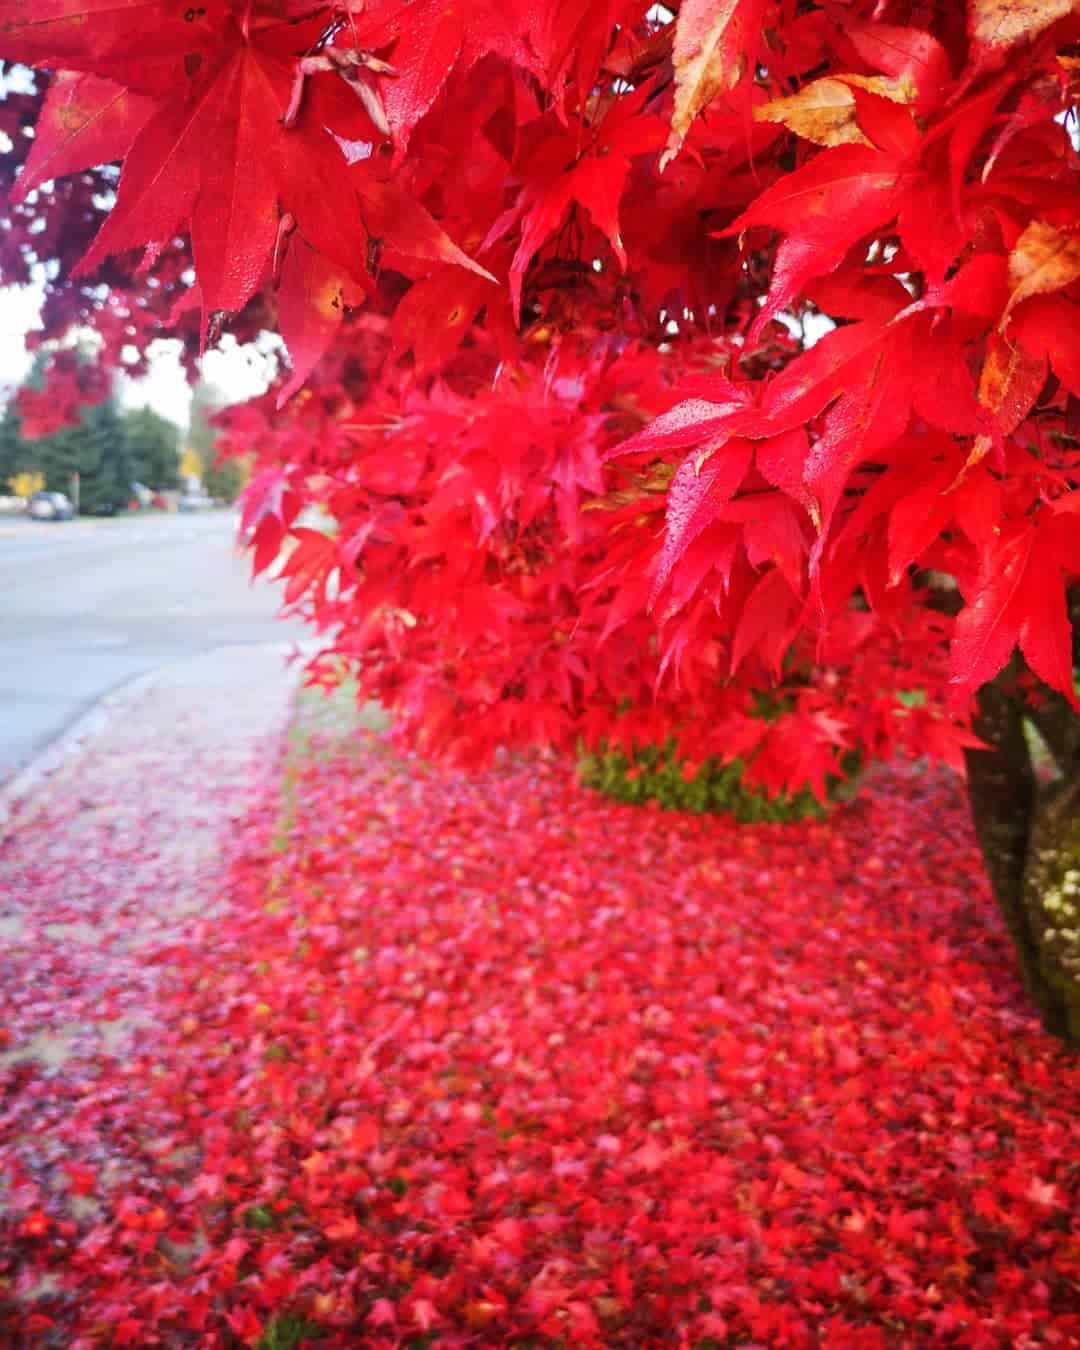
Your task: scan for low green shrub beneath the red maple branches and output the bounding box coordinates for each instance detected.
[578,740,860,824]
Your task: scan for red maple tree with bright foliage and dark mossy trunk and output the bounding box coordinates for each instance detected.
[0,0,1080,1040]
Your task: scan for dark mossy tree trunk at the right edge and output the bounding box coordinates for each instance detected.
[967,684,1080,1046]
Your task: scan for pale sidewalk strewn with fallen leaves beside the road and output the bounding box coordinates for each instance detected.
[0,644,298,1074]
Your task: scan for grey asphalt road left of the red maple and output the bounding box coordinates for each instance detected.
[0,512,311,782]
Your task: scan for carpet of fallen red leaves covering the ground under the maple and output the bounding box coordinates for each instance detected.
[0,736,1080,1350]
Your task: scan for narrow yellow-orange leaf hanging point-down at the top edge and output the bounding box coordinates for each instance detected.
[660,0,747,171]
